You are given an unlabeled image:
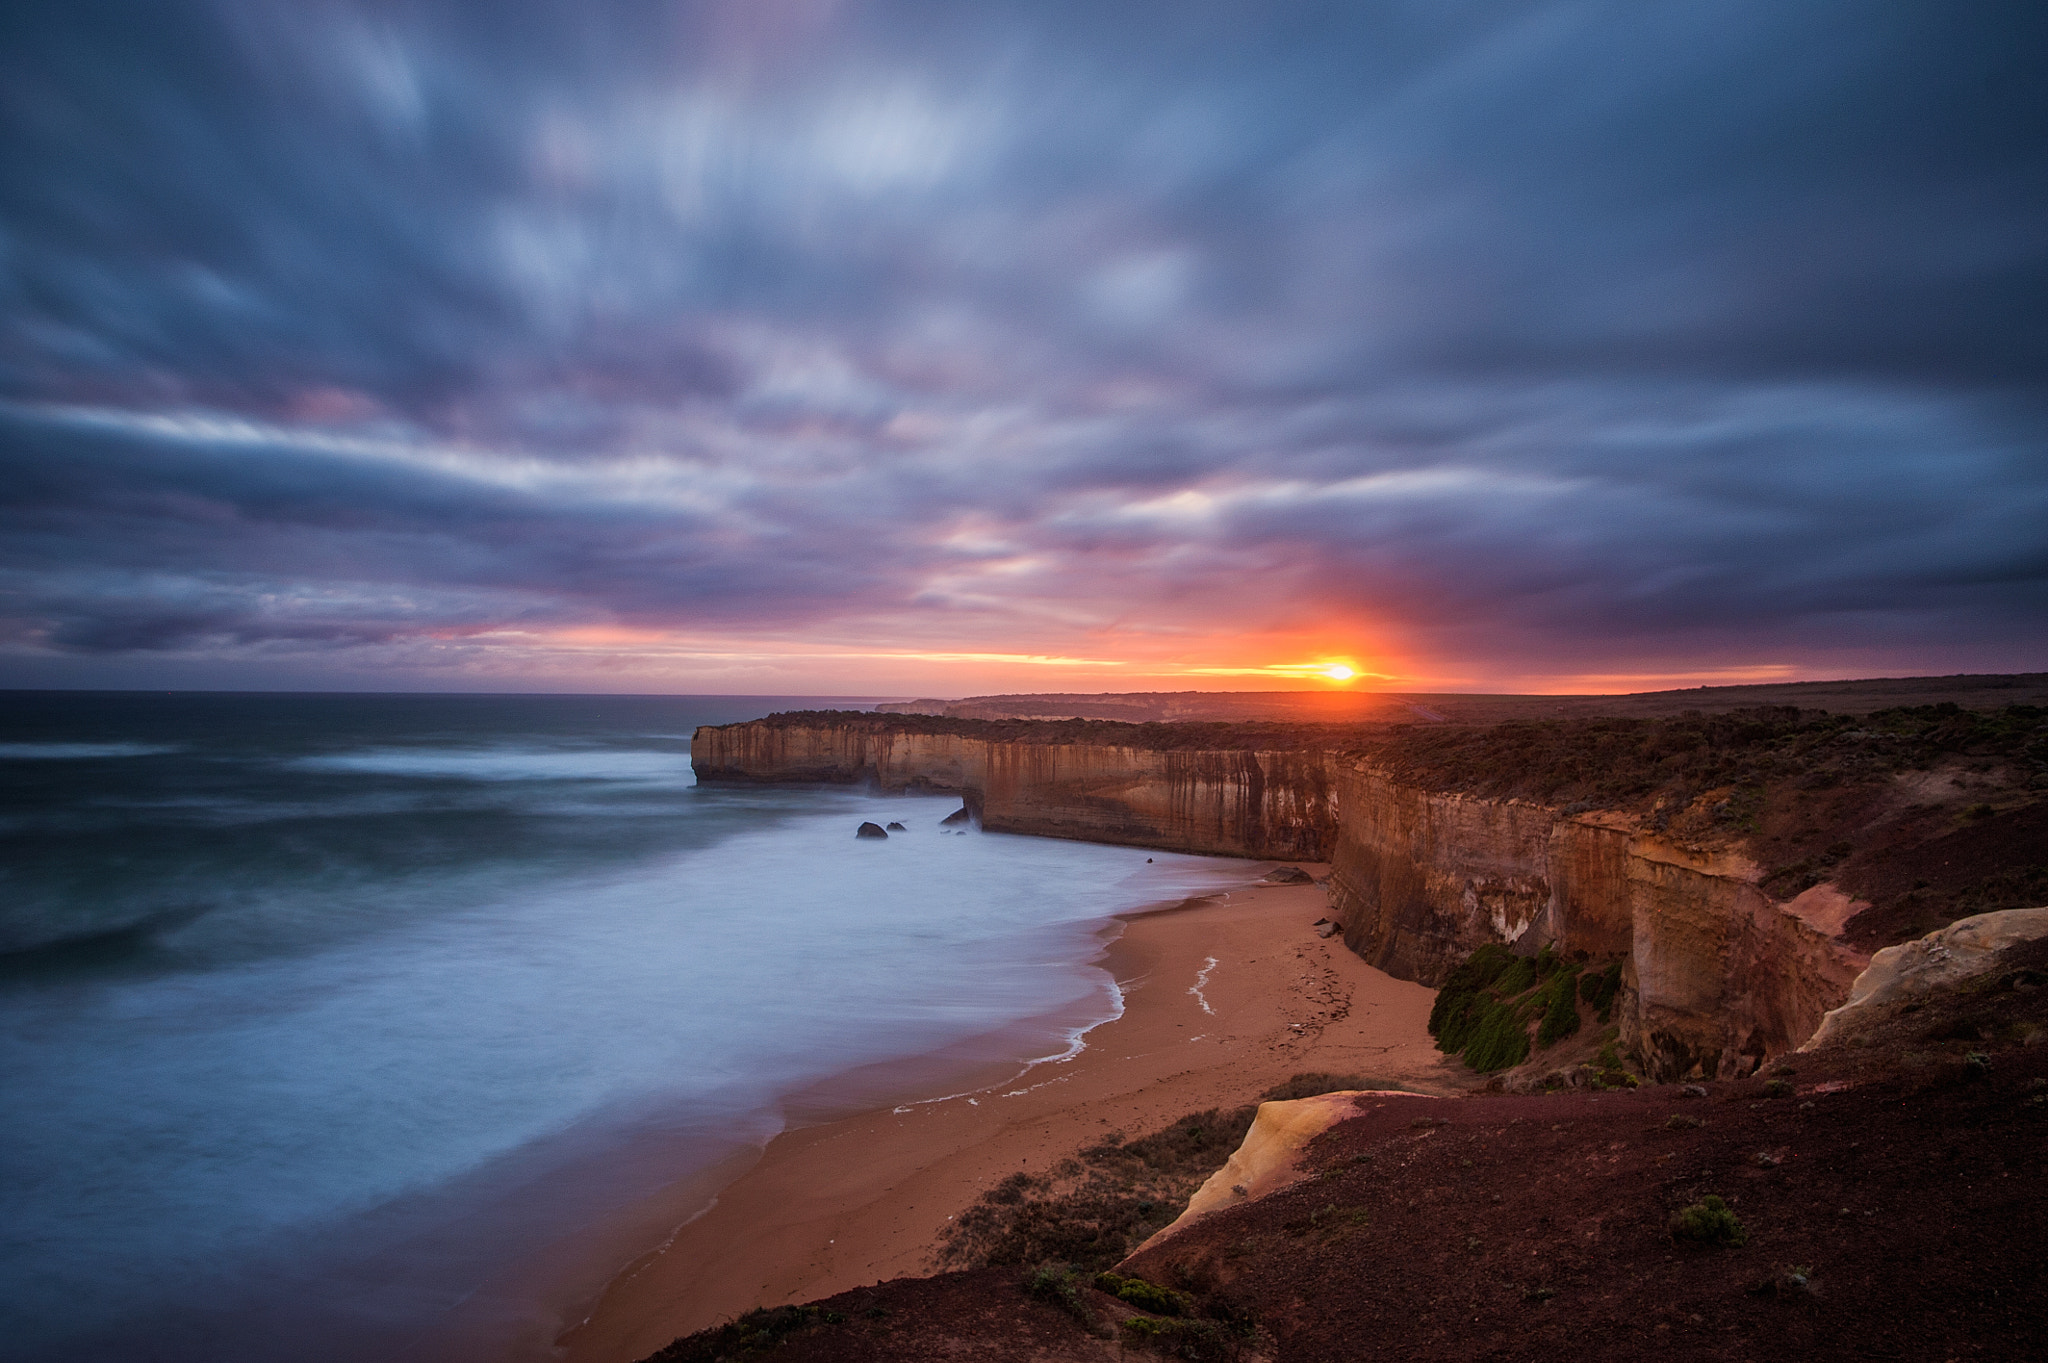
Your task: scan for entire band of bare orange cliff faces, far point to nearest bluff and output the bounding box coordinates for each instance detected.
[692,716,1866,1079]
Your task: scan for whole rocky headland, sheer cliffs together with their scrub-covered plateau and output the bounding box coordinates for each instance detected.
[692,704,2048,1079]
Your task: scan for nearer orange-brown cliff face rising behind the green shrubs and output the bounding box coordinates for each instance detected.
[1329,759,1864,1079]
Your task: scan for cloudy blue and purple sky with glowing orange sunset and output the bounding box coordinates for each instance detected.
[0,0,2048,696]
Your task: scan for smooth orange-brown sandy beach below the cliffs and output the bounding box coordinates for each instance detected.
[561,864,1470,1363]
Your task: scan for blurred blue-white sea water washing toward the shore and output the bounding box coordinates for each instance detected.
[0,692,1227,1363]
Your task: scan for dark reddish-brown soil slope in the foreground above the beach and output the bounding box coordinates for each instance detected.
[662,941,2048,1363]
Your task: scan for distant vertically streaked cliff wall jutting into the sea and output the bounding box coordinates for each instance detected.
[690,722,1337,862]
